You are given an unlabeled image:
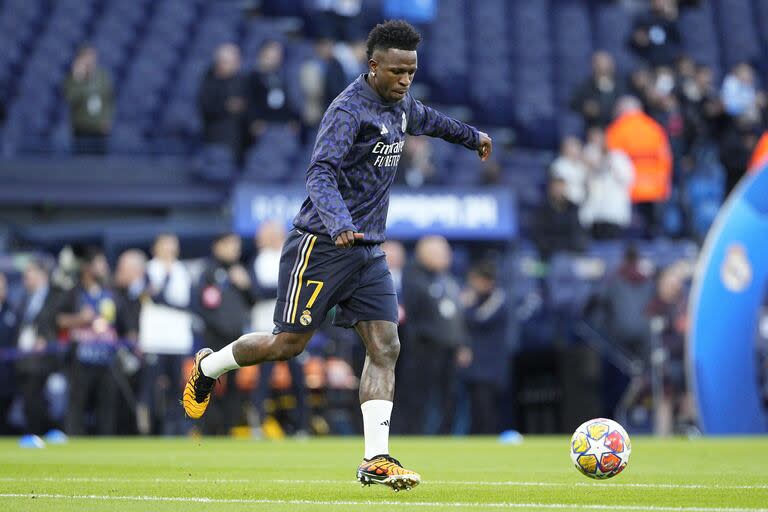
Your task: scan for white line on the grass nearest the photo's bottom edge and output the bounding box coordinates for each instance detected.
[0,493,768,512]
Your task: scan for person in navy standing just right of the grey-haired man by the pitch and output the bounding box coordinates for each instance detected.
[463,261,510,434]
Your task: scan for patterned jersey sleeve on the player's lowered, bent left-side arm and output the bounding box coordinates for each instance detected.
[307,108,359,240]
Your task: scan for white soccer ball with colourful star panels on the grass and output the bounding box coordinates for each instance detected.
[571,418,632,480]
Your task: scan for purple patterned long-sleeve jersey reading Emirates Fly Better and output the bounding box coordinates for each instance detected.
[293,75,480,243]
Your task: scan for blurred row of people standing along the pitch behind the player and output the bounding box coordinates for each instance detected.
[0,226,692,437]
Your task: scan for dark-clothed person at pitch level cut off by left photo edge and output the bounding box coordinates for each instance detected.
[0,272,18,435]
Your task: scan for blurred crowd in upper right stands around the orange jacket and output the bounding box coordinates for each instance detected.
[548,0,768,252]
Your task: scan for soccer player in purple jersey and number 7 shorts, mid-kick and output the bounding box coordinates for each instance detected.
[182,20,492,491]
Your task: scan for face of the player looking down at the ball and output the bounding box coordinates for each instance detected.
[368,48,418,101]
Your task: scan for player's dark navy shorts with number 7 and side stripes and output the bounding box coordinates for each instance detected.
[274,229,397,333]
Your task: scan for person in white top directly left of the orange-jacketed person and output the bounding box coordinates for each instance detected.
[579,127,635,240]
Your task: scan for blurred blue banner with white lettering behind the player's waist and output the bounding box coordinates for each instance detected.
[233,184,518,240]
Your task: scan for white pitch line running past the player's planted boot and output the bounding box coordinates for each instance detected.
[0,476,768,490]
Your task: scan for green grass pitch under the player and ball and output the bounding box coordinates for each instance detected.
[0,436,768,512]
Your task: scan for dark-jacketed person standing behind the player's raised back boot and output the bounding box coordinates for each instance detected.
[198,233,254,434]
